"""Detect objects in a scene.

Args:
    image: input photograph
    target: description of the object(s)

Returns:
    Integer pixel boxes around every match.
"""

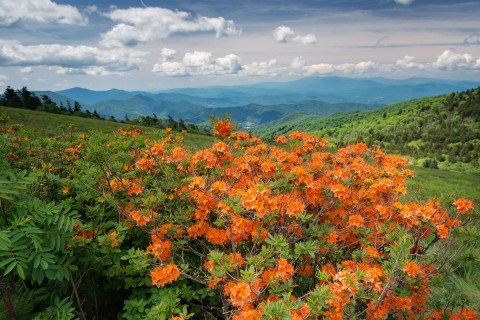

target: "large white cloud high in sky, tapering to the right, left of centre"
[101,7,241,48]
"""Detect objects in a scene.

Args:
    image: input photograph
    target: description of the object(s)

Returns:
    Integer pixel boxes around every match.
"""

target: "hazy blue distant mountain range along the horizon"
[36,77,479,128]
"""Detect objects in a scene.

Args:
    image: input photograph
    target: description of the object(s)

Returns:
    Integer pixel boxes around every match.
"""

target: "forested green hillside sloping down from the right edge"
[258,88,480,169]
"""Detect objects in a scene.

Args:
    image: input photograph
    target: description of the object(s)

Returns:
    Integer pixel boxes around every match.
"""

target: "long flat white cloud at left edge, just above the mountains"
[0,41,148,75]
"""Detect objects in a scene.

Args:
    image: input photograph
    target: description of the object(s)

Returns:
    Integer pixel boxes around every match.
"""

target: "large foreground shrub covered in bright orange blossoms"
[106,119,476,319]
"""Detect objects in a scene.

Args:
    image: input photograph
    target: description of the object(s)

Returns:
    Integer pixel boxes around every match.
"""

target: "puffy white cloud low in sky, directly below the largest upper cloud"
[152,50,243,76]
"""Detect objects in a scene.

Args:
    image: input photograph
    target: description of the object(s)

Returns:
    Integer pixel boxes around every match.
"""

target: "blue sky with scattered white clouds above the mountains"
[0,0,480,91]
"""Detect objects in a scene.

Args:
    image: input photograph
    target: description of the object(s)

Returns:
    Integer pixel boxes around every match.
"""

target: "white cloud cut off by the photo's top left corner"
[0,0,87,27]
